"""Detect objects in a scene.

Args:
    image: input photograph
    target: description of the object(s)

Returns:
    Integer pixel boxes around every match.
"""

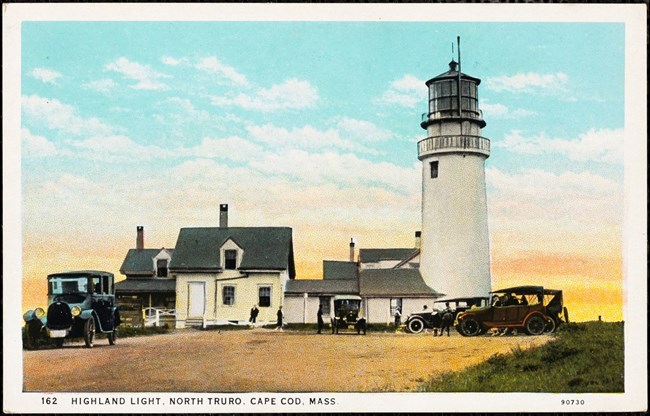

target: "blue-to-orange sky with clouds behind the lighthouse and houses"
[20,21,625,321]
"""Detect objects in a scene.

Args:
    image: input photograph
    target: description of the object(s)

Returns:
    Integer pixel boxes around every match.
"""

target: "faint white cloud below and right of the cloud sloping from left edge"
[68,135,177,163]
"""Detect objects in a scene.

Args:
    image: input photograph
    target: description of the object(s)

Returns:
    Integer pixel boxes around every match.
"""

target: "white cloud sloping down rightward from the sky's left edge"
[21,95,113,135]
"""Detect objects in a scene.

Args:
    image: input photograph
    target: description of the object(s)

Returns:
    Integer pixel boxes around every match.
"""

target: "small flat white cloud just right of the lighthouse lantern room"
[485,72,569,95]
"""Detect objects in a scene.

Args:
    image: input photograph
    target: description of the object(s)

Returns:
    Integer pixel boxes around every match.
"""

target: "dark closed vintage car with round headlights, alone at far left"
[23,270,120,348]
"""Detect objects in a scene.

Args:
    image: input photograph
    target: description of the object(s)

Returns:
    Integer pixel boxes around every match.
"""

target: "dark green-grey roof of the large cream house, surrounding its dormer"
[169,227,296,279]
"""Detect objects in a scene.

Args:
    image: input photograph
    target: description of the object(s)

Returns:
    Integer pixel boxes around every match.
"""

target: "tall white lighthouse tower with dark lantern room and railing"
[418,38,491,297]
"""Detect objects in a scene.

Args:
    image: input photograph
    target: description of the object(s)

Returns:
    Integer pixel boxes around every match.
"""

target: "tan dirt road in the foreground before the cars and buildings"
[23,328,549,392]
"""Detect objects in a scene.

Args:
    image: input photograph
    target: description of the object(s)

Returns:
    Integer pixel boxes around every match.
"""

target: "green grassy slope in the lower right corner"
[420,322,625,393]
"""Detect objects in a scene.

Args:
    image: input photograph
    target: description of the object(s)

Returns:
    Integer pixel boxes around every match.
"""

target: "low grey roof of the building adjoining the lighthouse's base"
[359,269,443,297]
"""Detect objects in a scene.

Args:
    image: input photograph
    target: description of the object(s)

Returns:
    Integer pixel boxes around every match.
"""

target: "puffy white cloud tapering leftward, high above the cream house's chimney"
[211,78,318,111]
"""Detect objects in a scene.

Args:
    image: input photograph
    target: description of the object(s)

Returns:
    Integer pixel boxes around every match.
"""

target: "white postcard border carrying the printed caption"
[2,3,647,413]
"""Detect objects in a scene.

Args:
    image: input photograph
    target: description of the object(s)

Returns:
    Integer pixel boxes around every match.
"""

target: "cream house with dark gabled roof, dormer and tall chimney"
[169,205,296,328]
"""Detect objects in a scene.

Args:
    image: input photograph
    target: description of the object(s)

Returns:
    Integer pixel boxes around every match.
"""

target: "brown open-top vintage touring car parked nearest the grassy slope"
[456,286,569,336]
